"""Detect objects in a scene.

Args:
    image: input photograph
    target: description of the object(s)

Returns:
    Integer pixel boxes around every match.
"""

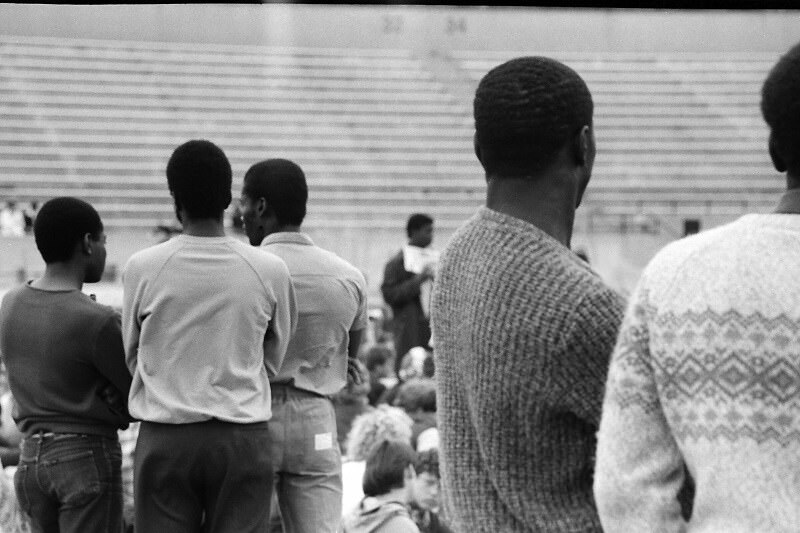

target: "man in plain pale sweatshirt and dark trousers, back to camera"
[123,141,297,533]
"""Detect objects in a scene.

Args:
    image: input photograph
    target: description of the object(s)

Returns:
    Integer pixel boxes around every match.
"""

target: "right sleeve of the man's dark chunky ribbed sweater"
[554,288,625,428]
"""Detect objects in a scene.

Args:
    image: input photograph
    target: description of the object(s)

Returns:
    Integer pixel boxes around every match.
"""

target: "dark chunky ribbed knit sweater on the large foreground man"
[432,208,623,533]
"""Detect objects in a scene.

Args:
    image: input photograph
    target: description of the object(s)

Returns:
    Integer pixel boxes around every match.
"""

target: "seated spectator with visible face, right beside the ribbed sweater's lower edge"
[408,449,452,533]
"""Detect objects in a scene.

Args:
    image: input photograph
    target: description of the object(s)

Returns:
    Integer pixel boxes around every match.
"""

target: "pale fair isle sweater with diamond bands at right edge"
[595,214,800,533]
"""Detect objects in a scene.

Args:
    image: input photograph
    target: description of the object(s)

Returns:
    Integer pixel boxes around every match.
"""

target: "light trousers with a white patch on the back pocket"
[269,384,342,533]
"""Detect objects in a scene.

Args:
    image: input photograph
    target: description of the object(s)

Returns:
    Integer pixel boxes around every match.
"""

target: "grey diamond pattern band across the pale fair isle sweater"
[615,309,800,445]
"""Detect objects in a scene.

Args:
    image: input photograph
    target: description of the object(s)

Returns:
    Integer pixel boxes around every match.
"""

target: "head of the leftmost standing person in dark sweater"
[33,197,106,283]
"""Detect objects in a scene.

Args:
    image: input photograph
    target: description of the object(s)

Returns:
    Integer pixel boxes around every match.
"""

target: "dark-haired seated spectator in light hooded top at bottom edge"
[344,440,419,533]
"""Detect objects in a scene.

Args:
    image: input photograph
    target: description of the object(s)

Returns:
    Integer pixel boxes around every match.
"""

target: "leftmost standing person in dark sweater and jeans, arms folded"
[0,197,131,533]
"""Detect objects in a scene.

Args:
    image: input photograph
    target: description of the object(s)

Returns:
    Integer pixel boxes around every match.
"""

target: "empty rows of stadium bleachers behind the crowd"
[0,36,783,228]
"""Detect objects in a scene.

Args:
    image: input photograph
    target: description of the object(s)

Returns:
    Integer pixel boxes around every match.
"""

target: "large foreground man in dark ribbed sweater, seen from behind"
[432,57,623,533]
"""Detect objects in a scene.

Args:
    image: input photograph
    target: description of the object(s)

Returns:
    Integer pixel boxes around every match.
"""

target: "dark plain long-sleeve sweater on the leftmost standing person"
[0,284,131,436]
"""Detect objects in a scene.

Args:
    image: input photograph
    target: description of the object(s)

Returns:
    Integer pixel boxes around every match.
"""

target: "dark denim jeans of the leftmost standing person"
[14,433,122,533]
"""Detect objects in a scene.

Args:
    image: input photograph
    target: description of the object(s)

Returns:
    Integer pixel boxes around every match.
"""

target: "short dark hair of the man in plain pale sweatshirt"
[167,140,232,219]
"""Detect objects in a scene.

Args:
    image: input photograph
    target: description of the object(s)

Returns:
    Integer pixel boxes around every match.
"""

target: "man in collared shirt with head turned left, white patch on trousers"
[241,159,368,533]
